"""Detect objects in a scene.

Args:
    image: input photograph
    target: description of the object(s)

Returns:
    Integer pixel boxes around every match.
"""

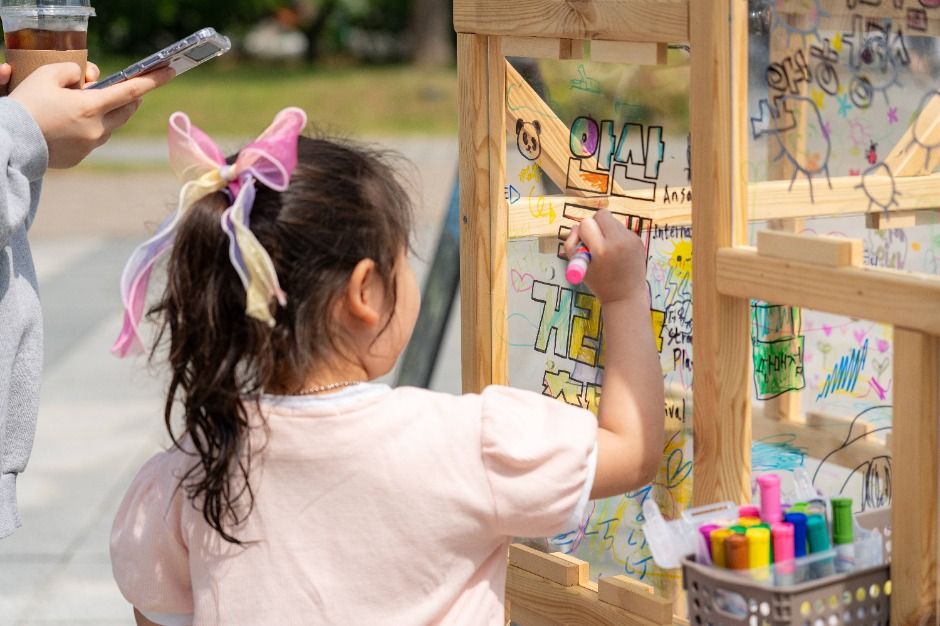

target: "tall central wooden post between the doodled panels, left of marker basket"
[689,0,751,505]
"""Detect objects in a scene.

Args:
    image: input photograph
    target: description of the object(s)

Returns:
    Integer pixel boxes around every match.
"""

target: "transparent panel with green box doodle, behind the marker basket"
[751,302,893,512]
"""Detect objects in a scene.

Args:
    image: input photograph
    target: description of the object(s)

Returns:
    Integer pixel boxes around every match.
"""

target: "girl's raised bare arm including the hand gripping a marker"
[565,211,664,498]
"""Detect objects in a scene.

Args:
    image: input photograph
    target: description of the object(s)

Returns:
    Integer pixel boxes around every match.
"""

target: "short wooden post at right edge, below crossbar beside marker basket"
[891,328,940,626]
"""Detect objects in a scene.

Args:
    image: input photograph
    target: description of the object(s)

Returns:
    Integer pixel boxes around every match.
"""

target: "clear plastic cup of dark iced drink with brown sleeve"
[0,0,95,90]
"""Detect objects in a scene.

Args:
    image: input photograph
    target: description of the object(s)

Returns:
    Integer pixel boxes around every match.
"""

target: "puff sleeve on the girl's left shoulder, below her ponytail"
[111,452,193,615]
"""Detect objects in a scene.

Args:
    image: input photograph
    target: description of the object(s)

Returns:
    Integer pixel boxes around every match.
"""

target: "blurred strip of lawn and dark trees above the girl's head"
[82,0,457,136]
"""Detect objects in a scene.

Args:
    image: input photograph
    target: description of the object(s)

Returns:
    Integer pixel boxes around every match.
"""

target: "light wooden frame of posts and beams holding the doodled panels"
[454,0,940,624]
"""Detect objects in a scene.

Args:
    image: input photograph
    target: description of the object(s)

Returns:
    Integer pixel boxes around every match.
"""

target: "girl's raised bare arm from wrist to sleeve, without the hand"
[592,292,664,497]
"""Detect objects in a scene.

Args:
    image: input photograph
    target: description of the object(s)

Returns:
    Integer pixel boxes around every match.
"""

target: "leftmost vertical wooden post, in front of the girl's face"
[457,34,508,393]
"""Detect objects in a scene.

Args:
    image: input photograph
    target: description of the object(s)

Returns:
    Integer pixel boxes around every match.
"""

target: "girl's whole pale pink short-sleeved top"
[111,385,597,626]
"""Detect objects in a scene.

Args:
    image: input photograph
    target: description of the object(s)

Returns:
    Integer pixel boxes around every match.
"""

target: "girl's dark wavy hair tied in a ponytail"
[150,137,412,544]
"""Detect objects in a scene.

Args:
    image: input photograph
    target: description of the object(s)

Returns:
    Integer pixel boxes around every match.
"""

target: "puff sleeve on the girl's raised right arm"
[480,387,597,537]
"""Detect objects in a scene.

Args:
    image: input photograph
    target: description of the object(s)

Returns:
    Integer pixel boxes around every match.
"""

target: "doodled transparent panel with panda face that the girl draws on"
[506,49,692,595]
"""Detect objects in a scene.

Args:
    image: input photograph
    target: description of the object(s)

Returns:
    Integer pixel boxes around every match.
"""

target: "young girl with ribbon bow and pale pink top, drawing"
[111,109,663,625]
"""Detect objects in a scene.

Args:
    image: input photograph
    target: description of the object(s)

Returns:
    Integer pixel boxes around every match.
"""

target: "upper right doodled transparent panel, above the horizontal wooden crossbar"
[748,0,940,241]
